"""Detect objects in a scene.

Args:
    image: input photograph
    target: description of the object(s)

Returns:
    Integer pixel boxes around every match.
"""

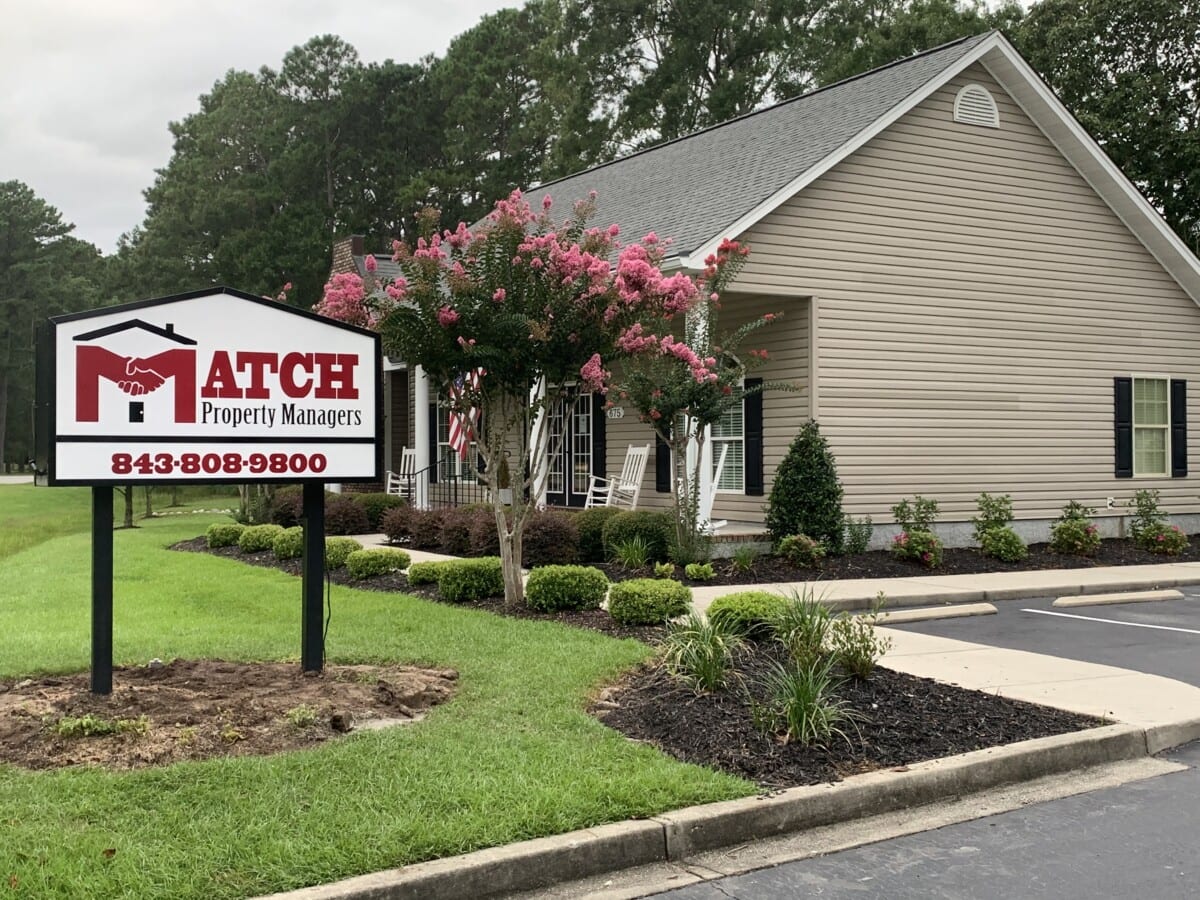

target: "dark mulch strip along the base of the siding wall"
[599,538,1200,586]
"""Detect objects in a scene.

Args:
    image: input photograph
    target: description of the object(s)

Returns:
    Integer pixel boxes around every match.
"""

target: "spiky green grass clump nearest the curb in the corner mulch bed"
[755,660,858,746]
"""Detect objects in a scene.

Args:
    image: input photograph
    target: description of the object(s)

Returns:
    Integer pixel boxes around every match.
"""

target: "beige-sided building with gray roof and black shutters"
[333,32,1200,542]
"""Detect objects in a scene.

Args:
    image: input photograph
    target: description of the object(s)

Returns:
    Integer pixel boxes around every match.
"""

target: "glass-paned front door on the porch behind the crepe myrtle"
[546,392,604,506]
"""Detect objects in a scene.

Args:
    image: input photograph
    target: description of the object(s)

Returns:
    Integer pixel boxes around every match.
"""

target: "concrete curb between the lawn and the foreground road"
[255,718,1200,900]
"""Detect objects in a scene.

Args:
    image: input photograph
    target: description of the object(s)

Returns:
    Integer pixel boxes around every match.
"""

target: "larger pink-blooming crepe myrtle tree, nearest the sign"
[316,191,696,605]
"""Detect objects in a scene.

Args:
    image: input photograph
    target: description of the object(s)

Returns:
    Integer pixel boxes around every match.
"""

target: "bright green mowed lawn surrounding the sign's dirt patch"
[0,496,755,898]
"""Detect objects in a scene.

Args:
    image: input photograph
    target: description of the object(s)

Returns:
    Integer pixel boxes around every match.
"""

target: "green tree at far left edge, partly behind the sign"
[0,181,102,466]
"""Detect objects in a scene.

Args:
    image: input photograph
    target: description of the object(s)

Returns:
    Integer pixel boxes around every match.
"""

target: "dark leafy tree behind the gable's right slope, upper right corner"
[1016,0,1200,253]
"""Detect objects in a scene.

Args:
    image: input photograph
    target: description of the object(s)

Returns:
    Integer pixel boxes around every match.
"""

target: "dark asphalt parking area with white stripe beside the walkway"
[889,595,1200,686]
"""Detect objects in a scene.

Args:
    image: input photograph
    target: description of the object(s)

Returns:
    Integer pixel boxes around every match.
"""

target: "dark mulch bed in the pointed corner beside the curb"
[593,648,1104,787]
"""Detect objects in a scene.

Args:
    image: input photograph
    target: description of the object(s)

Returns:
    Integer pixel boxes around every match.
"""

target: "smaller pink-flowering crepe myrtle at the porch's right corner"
[610,240,797,562]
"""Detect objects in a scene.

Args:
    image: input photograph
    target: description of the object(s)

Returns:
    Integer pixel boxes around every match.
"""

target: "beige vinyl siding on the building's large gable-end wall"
[738,66,1200,522]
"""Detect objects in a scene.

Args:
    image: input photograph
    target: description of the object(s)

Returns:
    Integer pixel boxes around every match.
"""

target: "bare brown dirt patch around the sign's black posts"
[0,660,458,769]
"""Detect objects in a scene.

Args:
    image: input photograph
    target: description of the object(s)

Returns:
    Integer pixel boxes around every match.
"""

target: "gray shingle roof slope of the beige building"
[529,32,994,256]
